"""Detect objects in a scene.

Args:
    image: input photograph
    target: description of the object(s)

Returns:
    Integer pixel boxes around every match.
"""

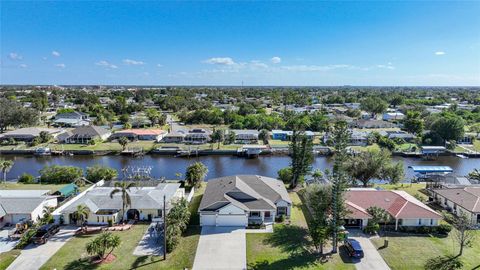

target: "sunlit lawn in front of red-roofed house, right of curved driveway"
[372,231,480,270]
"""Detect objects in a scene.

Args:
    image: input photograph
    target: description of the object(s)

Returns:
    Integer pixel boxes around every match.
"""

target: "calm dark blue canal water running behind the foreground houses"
[2,155,480,179]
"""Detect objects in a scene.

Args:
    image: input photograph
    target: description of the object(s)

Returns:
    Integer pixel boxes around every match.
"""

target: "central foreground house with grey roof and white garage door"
[198,175,292,227]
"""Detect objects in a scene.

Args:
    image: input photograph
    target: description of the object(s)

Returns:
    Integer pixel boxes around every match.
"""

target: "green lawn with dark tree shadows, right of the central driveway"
[247,193,355,270]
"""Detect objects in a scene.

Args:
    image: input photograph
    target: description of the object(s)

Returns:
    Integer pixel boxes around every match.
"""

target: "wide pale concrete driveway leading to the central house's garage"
[193,226,247,270]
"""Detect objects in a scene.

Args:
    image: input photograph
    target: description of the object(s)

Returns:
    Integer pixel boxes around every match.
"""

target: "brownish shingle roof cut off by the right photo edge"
[433,187,480,213]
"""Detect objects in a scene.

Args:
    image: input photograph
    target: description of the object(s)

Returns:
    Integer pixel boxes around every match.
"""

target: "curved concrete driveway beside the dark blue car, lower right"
[350,235,390,270]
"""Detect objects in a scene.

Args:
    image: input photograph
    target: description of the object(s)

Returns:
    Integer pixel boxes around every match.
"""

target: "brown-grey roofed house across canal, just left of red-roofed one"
[57,126,112,144]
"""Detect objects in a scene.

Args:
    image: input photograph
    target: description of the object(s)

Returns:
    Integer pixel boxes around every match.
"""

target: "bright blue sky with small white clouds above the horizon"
[0,0,480,86]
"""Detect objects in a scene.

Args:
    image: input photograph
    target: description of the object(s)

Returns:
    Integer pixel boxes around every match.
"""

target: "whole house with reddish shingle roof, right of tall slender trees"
[345,188,442,230]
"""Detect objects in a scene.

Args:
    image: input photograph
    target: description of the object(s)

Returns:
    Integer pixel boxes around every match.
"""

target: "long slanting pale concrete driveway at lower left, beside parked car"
[7,227,78,270]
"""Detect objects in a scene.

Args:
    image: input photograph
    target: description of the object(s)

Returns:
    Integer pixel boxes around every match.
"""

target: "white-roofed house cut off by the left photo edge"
[0,190,57,228]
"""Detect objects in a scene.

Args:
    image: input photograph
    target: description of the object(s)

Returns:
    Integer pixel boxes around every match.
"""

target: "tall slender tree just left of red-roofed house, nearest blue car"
[330,121,351,253]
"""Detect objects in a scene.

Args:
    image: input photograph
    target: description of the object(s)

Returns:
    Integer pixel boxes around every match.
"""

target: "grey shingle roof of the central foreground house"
[199,175,291,211]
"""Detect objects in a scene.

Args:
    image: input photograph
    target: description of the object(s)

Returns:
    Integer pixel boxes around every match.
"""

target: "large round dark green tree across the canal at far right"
[430,116,465,143]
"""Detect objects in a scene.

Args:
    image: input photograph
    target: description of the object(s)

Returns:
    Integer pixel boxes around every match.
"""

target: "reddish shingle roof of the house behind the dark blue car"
[345,189,442,219]
